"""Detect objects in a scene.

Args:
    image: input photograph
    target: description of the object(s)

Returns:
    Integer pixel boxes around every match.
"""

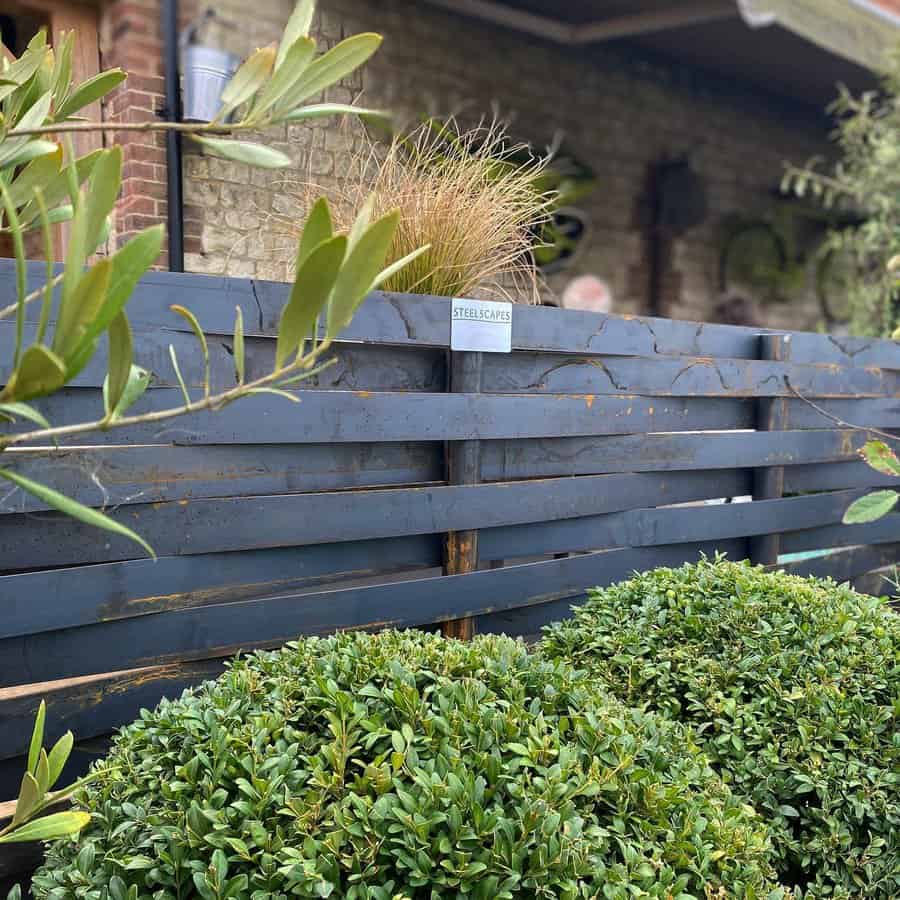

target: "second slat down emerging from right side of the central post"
[481,429,867,486]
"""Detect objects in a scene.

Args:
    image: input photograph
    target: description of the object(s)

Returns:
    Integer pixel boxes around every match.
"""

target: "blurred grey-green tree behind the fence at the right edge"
[784,54,900,336]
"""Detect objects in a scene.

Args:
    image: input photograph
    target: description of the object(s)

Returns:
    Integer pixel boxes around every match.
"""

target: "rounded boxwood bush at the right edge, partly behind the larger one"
[542,559,900,900]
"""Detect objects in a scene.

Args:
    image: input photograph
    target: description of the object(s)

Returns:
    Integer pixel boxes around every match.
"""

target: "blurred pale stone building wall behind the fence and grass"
[179,0,827,328]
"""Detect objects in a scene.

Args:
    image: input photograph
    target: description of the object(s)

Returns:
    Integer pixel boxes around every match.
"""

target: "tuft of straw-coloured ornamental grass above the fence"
[255,120,554,302]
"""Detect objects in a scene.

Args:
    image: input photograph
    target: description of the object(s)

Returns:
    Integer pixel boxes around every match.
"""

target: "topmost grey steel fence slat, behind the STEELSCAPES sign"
[7,260,900,369]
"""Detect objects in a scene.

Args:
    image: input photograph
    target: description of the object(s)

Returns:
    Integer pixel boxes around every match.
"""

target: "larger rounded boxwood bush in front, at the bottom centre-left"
[34,632,783,900]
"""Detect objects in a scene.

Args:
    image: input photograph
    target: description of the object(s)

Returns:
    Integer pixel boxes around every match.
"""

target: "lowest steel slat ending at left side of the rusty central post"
[0,535,441,638]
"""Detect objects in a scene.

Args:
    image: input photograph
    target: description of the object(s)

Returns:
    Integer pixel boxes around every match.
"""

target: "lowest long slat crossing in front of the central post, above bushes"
[0,544,744,685]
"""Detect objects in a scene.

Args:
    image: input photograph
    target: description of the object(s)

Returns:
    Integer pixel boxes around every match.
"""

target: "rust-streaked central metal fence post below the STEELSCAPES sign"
[441,350,482,640]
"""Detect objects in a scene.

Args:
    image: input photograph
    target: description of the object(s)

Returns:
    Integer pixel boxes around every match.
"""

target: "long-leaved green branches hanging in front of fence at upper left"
[0,0,426,555]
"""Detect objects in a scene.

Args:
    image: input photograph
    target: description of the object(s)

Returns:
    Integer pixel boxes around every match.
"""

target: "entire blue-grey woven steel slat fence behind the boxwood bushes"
[0,264,900,816]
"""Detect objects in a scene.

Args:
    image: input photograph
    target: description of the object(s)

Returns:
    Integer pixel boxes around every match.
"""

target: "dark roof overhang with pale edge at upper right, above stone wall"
[428,0,888,109]
